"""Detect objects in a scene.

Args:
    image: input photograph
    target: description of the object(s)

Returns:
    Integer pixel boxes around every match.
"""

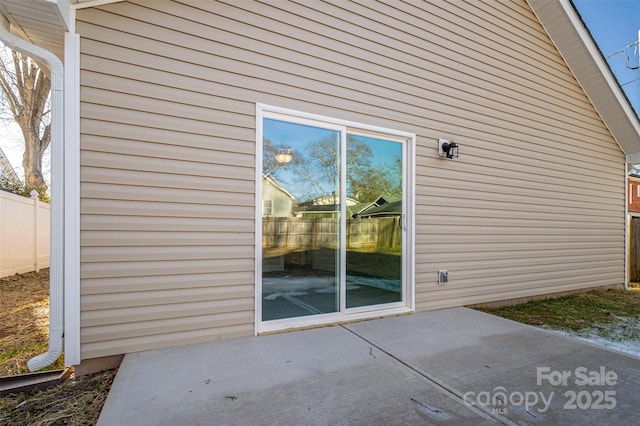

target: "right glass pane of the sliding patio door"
[346,134,405,308]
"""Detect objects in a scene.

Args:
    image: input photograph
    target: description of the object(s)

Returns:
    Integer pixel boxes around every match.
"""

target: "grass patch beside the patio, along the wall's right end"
[478,286,640,337]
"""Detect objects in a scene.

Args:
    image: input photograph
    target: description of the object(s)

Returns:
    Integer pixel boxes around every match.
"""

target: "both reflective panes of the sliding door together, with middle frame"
[261,113,406,321]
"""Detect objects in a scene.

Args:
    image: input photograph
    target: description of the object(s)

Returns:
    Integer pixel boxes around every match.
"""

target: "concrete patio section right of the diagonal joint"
[346,308,640,425]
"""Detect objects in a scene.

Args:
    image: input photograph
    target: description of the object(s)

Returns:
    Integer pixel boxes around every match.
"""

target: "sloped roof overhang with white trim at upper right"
[527,0,640,162]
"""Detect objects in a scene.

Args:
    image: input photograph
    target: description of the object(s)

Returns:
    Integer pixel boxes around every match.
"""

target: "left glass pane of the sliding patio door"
[262,119,341,321]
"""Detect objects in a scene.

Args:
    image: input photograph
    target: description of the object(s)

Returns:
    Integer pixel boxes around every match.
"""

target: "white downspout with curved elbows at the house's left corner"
[0,20,64,371]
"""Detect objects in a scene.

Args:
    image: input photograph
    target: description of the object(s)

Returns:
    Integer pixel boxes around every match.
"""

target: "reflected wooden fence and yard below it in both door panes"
[262,217,402,321]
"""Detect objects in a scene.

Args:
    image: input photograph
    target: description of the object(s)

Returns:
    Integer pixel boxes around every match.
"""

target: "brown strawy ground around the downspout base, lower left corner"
[0,269,115,426]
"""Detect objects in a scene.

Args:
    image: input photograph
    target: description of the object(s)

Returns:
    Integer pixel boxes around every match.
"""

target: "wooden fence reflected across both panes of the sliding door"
[262,217,402,250]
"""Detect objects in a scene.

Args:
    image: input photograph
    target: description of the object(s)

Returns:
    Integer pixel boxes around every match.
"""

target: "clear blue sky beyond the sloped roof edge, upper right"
[573,0,640,115]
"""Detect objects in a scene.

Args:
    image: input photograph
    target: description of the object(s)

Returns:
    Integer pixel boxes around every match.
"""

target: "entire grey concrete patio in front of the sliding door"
[98,308,640,426]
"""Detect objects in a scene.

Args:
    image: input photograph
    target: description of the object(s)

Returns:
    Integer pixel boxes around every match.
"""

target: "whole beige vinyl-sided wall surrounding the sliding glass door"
[77,0,625,358]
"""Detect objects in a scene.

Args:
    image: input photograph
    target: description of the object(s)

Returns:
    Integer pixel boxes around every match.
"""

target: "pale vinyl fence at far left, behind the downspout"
[0,191,51,278]
